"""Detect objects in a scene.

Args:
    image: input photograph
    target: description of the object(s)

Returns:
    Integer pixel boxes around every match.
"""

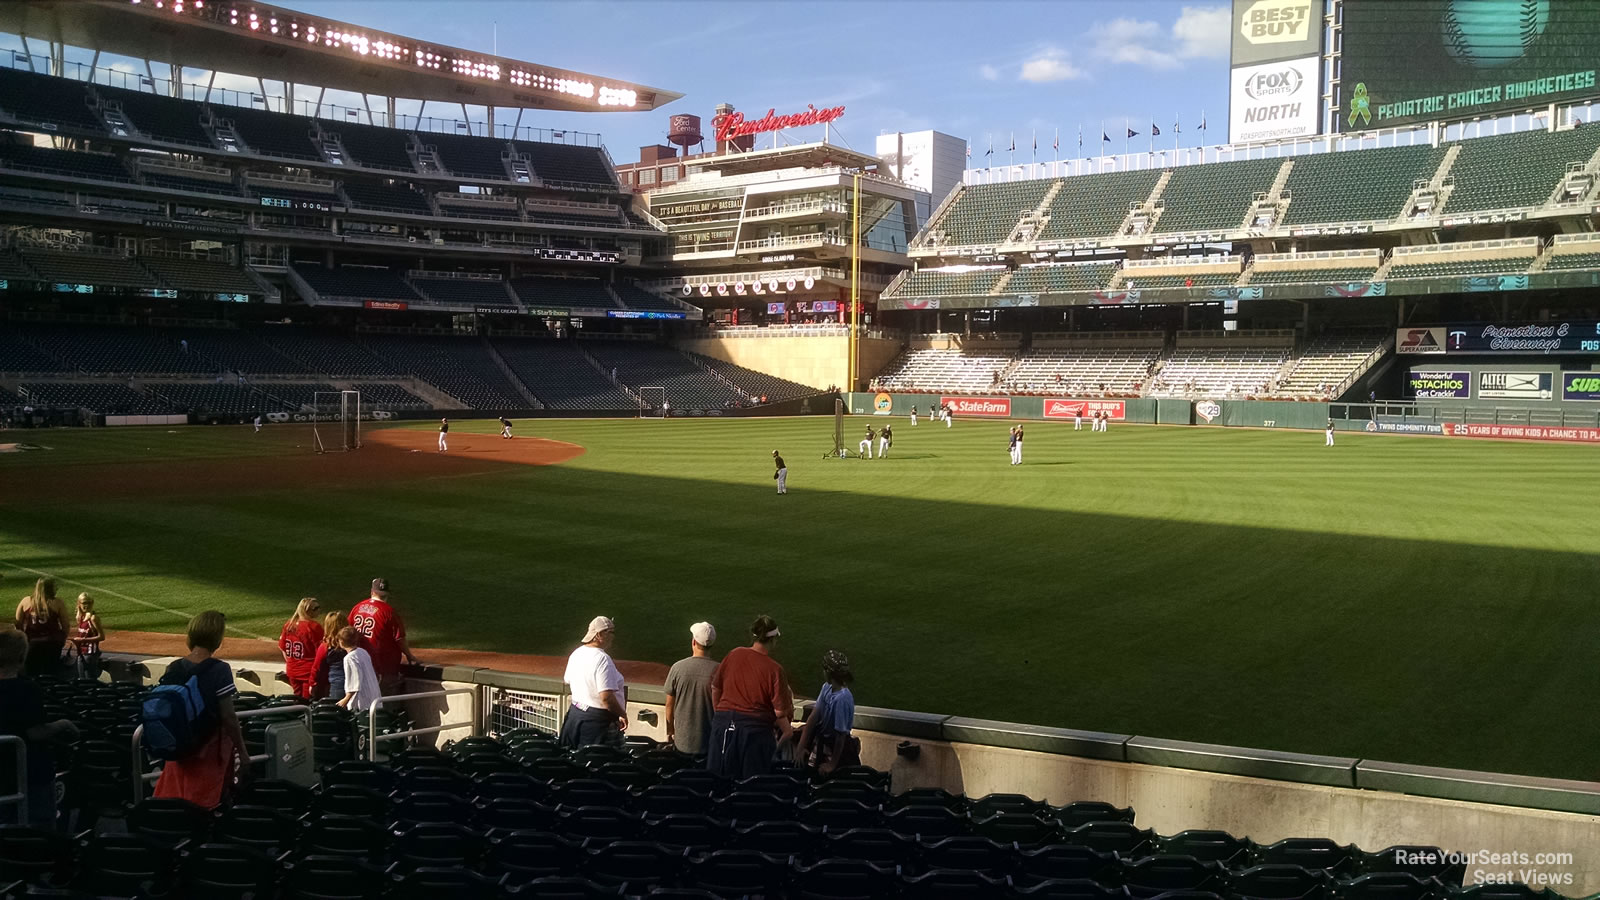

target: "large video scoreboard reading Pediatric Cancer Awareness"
[1336,0,1600,131]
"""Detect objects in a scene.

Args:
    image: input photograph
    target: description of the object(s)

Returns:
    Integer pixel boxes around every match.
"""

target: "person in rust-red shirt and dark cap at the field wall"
[706,615,795,778]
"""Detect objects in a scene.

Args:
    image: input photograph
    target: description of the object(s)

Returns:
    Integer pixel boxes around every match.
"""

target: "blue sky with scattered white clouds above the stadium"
[294,0,1229,165]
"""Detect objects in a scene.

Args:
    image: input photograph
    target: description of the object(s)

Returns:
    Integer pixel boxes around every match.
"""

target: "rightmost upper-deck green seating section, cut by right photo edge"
[1445,128,1600,213]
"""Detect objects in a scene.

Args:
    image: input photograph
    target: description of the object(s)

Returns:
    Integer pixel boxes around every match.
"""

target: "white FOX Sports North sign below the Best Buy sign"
[1227,56,1322,144]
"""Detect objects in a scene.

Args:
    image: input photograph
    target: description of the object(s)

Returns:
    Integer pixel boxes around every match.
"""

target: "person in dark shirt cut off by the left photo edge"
[0,628,78,828]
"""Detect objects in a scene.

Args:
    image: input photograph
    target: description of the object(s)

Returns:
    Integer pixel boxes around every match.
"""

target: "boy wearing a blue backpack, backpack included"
[141,610,246,809]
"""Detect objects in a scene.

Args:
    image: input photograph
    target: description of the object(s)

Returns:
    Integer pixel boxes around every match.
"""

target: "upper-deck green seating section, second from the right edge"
[1283,146,1445,226]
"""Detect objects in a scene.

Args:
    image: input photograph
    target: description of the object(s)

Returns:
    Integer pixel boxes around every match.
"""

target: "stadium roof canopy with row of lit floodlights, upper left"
[0,0,683,112]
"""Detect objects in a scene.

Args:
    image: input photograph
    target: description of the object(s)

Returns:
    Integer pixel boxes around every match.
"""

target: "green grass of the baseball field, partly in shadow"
[0,416,1600,778]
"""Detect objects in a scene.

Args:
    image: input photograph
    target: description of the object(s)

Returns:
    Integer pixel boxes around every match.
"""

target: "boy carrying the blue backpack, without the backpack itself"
[155,610,246,809]
